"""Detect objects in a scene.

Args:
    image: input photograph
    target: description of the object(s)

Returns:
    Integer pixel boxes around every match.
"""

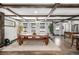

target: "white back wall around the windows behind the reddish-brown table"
[21,21,52,35]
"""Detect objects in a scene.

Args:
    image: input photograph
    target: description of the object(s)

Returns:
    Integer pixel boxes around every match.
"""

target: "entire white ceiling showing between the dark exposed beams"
[0,8,79,19]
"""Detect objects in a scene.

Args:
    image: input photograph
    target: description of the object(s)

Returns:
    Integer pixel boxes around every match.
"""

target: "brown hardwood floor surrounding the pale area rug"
[0,36,79,55]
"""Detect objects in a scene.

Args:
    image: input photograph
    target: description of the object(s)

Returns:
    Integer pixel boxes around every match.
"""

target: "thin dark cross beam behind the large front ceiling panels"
[5,15,79,17]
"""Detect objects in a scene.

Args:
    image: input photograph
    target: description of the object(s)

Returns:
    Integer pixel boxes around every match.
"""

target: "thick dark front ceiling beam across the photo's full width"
[0,3,79,8]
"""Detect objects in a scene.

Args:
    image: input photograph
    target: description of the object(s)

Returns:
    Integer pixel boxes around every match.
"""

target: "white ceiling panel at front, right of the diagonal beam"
[52,8,79,15]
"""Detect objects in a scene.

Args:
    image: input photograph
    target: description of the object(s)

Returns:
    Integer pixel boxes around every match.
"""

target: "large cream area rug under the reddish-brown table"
[0,40,61,51]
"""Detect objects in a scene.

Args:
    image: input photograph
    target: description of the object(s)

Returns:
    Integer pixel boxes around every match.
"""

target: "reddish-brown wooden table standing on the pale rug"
[17,35,49,45]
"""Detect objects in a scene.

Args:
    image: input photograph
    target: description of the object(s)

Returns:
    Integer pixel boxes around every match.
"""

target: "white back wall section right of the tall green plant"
[54,21,72,35]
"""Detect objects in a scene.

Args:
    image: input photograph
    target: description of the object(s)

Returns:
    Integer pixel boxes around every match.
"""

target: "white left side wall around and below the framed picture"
[5,18,18,40]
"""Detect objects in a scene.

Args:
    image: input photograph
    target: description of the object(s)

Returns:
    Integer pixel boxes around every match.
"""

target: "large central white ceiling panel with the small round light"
[10,8,51,15]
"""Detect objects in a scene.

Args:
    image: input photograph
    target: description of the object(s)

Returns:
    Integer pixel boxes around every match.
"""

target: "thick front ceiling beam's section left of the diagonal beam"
[0,3,54,8]
